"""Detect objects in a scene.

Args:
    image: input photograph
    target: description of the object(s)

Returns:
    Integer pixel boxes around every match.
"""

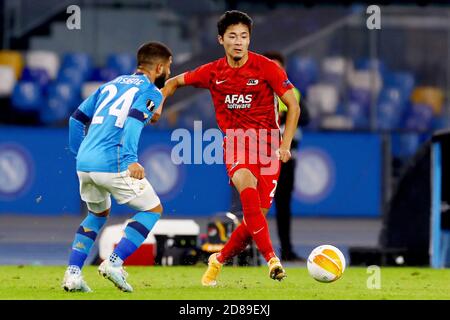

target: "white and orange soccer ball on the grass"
[307,245,345,282]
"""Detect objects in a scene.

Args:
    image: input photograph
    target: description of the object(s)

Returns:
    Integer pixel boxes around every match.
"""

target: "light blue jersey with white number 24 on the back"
[69,74,163,172]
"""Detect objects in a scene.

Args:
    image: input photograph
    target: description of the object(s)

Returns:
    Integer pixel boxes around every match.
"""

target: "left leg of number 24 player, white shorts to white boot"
[62,172,111,292]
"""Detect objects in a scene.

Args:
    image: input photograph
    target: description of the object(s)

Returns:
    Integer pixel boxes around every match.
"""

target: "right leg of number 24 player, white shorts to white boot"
[99,177,163,292]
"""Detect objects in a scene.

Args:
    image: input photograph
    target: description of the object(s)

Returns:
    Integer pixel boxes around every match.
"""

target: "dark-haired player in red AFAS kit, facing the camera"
[162,10,300,286]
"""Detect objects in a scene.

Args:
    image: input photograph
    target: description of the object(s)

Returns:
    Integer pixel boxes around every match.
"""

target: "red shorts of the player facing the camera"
[224,139,281,209]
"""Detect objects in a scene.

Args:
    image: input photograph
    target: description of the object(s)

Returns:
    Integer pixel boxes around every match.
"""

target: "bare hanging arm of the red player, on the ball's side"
[280,89,300,162]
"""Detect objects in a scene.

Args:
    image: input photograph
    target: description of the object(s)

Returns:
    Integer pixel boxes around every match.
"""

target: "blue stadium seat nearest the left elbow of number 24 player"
[41,82,80,125]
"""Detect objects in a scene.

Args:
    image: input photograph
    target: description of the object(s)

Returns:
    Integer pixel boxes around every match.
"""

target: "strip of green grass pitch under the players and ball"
[0,266,450,300]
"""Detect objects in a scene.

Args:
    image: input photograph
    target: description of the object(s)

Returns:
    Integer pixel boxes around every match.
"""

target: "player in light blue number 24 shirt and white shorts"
[62,42,172,292]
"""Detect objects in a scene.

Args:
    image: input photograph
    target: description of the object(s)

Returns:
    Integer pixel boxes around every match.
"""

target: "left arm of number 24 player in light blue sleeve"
[69,90,98,155]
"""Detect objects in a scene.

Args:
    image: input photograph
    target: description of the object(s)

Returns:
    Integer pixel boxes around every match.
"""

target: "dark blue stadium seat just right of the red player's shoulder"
[286,56,319,95]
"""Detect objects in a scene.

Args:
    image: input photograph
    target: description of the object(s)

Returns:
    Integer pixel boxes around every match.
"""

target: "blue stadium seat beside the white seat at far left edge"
[11,81,44,111]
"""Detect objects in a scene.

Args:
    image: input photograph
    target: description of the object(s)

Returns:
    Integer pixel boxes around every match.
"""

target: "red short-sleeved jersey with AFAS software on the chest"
[184,51,293,133]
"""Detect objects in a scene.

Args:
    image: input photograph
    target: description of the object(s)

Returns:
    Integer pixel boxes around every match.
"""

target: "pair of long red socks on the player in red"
[217,188,275,263]
